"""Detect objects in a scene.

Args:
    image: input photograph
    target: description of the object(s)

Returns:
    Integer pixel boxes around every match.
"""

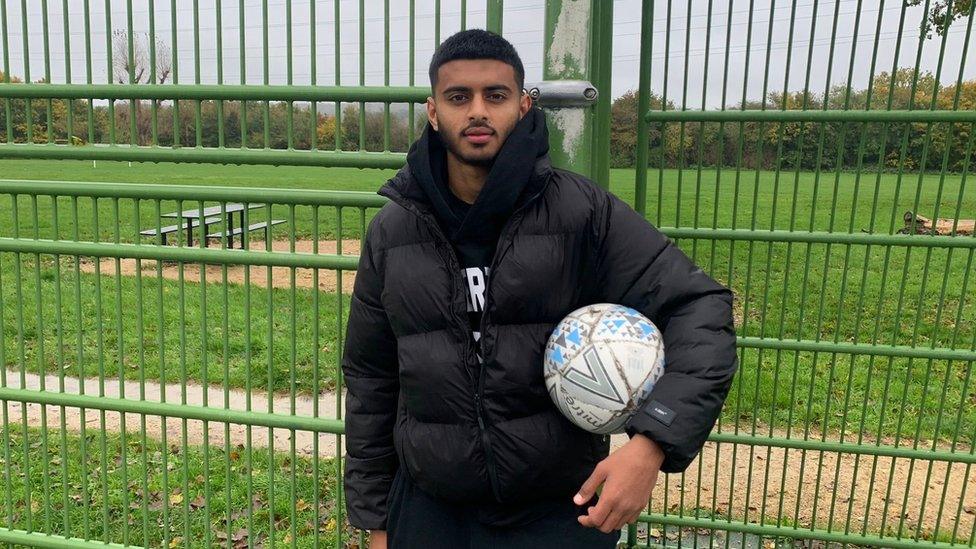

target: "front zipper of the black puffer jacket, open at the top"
[380,181,549,502]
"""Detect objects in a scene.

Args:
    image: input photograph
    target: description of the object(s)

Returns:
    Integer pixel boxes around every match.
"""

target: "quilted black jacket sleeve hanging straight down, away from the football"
[342,226,399,530]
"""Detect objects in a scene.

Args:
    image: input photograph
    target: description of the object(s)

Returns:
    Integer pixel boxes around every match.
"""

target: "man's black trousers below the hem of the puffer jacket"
[386,467,620,549]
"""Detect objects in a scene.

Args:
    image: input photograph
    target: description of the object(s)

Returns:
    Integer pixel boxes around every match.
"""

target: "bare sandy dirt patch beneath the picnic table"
[81,239,359,294]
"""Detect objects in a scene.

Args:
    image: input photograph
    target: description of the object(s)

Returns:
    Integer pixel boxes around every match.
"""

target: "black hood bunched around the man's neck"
[379,107,552,242]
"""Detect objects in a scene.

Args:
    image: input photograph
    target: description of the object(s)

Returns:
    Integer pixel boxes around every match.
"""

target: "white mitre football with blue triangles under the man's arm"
[543,303,664,434]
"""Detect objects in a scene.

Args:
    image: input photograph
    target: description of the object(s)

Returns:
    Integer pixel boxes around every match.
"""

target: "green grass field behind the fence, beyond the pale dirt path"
[0,155,976,442]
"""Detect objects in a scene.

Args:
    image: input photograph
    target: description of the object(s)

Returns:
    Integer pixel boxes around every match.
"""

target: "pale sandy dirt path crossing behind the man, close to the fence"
[7,372,976,538]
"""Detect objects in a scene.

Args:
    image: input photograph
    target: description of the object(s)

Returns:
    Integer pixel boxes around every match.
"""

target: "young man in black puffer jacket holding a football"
[342,30,736,549]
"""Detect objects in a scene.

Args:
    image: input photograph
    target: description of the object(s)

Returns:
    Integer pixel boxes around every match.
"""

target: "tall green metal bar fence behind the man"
[0,0,976,547]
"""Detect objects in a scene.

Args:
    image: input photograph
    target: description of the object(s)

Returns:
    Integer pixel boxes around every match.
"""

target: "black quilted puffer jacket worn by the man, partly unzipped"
[342,109,736,529]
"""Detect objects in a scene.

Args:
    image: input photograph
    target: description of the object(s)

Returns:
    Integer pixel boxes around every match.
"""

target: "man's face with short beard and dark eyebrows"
[427,59,532,166]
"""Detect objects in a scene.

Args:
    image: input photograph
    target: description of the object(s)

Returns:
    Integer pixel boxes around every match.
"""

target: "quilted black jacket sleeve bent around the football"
[594,189,738,473]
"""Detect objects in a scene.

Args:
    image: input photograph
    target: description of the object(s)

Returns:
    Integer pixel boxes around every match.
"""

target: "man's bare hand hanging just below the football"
[573,434,664,534]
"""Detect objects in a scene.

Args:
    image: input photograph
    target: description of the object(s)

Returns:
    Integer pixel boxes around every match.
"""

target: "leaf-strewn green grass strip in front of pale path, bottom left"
[0,426,353,548]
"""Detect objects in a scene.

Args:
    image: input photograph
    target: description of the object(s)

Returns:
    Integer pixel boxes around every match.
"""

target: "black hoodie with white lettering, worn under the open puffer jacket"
[407,108,549,357]
